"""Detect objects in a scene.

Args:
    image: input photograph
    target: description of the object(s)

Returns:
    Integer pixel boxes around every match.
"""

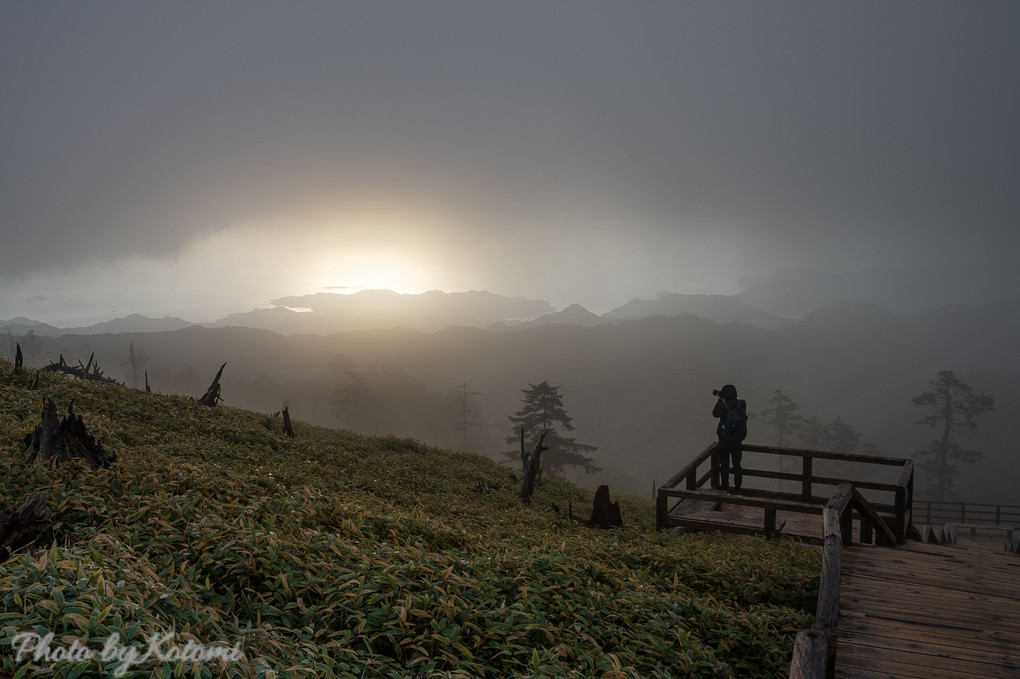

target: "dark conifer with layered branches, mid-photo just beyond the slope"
[506,381,600,473]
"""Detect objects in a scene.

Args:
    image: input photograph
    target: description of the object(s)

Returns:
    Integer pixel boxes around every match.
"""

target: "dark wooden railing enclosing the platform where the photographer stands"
[656,443,914,543]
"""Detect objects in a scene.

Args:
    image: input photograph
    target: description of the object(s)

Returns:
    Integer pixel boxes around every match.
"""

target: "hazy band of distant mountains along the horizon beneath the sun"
[0,268,1010,336]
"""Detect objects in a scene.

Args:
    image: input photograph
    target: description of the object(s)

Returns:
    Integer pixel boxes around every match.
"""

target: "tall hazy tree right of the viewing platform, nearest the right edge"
[913,370,996,501]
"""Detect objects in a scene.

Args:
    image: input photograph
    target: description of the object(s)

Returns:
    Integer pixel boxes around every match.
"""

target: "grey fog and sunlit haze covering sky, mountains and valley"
[0,0,1020,504]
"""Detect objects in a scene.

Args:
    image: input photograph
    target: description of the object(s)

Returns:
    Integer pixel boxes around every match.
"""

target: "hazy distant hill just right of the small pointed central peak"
[604,293,792,328]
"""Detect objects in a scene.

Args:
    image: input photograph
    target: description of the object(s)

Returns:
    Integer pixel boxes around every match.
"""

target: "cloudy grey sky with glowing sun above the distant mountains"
[0,0,1020,324]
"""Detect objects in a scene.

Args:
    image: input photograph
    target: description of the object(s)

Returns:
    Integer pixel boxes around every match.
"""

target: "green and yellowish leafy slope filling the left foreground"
[0,362,819,677]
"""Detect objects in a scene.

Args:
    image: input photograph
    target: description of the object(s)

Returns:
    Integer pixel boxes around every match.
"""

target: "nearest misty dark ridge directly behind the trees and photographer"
[9,291,1020,502]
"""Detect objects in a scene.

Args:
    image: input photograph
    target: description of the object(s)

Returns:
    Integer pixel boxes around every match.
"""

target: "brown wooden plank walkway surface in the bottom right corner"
[835,540,1020,679]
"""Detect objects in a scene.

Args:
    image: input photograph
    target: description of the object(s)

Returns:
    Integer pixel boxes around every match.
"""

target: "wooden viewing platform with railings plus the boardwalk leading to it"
[656,445,1020,679]
